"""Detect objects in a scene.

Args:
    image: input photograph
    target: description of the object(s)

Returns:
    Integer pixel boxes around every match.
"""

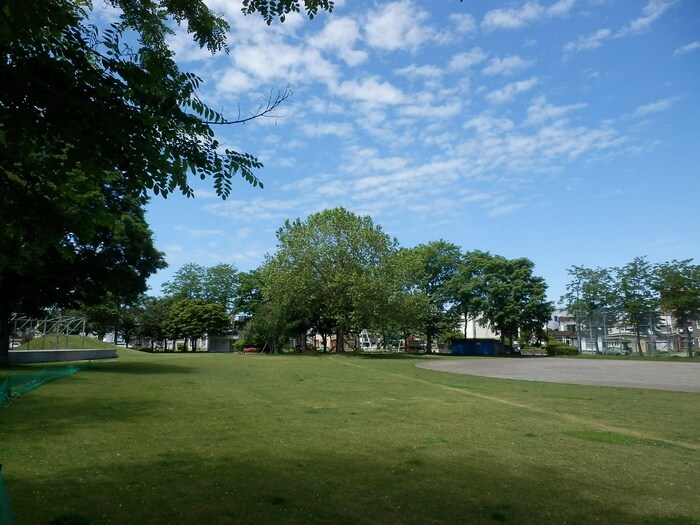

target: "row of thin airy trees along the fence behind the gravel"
[561,257,700,356]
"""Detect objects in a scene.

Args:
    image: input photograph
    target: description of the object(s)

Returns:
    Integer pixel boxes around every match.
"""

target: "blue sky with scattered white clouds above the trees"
[135,0,700,300]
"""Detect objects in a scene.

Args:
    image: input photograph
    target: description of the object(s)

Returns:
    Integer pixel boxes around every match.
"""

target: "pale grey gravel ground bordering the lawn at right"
[418,357,700,392]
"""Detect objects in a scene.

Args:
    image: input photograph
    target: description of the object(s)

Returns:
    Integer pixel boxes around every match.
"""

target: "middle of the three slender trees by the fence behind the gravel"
[614,257,659,356]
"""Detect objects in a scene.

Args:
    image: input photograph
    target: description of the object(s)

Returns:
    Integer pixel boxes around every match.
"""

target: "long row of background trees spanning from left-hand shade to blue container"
[69,208,552,352]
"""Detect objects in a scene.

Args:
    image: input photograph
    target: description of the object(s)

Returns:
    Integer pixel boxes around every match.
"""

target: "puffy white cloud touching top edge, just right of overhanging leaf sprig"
[364,0,435,51]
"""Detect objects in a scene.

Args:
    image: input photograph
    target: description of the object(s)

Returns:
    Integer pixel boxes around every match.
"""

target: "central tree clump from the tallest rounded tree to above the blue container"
[236,208,552,351]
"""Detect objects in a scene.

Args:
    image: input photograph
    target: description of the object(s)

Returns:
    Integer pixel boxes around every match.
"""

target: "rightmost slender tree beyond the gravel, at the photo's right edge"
[653,259,700,357]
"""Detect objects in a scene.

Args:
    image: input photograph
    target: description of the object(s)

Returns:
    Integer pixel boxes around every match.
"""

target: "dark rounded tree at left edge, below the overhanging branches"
[0,175,165,365]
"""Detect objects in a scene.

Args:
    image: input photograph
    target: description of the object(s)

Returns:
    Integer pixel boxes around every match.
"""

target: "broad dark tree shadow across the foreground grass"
[6,444,697,525]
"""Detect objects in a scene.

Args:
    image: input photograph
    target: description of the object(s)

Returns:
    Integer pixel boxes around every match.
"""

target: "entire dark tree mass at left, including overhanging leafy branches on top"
[0,0,333,365]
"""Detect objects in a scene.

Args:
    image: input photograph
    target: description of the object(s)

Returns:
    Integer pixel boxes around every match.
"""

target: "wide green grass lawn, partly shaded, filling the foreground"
[0,350,700,525]
